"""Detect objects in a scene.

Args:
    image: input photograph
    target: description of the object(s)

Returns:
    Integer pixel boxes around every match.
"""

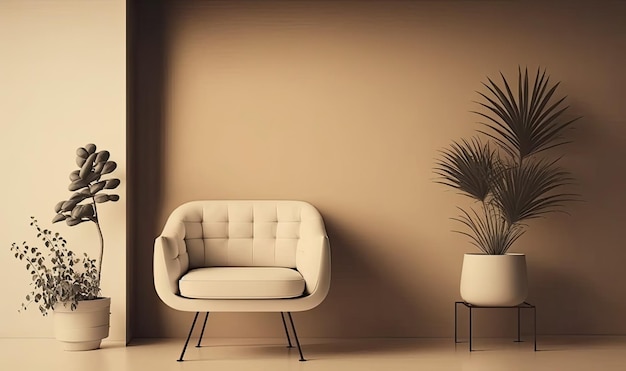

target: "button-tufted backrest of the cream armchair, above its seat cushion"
[161,200,326,269]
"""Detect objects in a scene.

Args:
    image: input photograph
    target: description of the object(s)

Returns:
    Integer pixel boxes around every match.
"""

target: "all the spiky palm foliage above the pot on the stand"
[434,67,579,255]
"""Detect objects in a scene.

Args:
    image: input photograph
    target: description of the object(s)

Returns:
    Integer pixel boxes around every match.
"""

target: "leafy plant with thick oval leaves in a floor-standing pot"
[11,144,120,350]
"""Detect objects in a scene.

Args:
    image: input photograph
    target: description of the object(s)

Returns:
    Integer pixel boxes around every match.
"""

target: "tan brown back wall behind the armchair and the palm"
[134,1,626,337]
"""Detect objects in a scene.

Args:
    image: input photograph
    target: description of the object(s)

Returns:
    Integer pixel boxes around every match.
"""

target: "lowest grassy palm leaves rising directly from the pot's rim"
[452,203,524,255]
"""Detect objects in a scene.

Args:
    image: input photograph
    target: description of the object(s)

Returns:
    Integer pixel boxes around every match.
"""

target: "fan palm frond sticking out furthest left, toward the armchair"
[434,138,498,201]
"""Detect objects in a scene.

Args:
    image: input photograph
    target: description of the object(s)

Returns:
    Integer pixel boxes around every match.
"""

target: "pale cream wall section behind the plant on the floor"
[0,0,126,341]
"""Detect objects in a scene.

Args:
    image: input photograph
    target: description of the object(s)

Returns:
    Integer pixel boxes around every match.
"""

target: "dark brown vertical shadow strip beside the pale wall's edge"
[127,1,167,337]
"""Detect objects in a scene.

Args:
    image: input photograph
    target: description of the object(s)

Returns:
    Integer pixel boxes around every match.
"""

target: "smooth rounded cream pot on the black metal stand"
[461,253,528,307]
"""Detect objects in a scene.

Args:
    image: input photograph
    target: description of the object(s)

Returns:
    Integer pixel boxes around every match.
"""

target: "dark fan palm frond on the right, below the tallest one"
[493,159,576,224]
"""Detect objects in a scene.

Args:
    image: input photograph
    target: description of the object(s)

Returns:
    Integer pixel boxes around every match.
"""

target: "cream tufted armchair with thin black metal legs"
[154,200,330,361]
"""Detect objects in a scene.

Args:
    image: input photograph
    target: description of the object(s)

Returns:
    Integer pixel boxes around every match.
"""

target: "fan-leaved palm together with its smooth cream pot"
[435,68,578,306]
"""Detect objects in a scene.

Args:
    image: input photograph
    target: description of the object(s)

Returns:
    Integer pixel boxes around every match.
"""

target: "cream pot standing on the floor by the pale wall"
[53,298,111,351]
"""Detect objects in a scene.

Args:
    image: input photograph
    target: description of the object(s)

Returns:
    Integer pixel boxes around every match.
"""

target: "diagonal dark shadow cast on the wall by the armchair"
[302,215,420,337]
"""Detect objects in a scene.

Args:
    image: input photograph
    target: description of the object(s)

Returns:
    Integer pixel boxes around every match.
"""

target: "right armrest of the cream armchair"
[296,235,331,307]
